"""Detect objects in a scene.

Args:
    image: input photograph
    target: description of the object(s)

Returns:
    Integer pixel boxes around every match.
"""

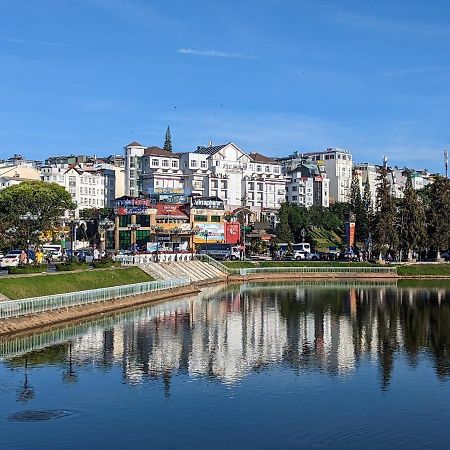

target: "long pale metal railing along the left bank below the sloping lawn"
[0,278,190,319]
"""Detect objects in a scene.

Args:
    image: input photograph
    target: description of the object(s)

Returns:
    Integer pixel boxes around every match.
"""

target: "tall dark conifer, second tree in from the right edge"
[399,173,426,260]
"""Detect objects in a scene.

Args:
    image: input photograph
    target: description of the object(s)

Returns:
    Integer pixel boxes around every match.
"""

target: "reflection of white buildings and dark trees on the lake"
[0,283,450,392]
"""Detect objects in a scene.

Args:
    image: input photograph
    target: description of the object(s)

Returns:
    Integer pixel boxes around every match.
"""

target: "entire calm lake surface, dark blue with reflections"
[0,282,450,449]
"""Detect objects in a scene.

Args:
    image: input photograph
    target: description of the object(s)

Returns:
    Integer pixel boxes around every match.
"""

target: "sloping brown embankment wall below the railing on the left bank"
[0,285,200,336]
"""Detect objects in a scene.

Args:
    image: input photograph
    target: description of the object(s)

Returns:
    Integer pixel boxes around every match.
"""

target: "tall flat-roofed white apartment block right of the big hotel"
[303,148,352,203]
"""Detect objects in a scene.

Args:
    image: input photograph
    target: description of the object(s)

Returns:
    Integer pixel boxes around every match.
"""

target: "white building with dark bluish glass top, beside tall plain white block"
[286,160,330,208]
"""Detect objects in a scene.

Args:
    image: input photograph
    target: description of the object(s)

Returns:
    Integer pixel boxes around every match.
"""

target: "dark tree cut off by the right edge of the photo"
[427,177,450,258]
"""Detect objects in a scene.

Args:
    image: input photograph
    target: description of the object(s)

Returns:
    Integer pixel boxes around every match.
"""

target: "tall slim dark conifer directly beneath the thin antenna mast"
[373,168,398,255]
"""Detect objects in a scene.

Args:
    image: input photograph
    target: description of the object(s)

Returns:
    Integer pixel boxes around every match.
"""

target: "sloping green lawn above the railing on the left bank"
[0,267,152,299]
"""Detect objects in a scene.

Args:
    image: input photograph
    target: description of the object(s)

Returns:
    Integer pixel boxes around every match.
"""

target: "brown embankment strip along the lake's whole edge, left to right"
[0,273,450,337]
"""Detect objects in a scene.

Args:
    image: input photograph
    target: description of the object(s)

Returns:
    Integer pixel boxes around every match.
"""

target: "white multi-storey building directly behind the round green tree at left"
[41,164,106,210]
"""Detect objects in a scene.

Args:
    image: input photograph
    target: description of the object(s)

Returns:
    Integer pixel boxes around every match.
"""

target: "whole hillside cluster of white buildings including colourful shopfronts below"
[0,142,432,249]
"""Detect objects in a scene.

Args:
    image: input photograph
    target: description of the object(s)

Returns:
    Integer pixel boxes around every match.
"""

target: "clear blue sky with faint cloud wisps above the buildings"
[0,0,450,171]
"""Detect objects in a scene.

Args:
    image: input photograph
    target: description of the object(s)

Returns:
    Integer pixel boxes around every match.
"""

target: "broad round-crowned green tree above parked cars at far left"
[0,181,75,248]
